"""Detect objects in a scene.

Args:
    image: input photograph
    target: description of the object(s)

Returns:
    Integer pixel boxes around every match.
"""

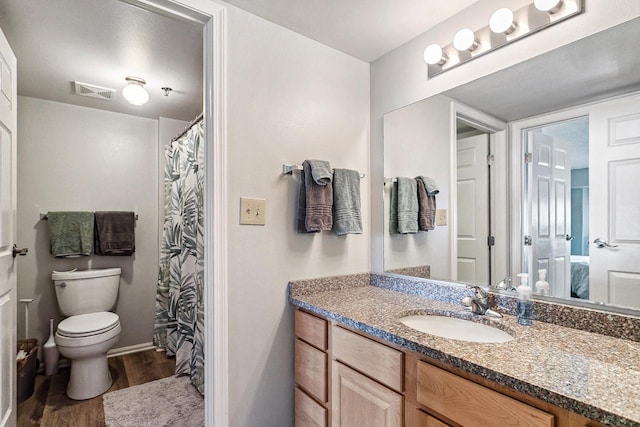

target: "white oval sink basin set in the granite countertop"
[400,314,513,343]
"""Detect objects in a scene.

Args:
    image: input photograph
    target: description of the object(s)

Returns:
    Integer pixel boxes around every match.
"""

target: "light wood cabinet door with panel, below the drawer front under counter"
[331,361,403,427]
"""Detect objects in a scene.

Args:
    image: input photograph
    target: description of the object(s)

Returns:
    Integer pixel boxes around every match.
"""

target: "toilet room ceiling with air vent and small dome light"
[0,0,203,121]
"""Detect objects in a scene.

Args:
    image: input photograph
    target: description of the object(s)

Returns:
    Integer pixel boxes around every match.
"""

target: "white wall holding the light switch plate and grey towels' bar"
[227,6,369,427]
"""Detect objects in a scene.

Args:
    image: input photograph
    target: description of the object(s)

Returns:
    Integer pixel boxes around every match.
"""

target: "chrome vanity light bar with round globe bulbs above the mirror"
[424,0,585,78]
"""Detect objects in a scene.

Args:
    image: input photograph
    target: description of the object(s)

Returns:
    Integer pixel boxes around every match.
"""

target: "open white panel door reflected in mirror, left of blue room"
[527,128,571,298]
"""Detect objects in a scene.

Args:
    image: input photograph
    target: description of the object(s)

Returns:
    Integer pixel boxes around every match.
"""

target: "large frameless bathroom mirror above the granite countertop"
[384,18,640,309]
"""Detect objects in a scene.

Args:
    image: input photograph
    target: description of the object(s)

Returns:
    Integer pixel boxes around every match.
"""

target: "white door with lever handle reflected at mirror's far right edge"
[589,95,640,308]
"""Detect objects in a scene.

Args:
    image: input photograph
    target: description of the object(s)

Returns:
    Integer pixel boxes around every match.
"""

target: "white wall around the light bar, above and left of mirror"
[370,0,640,271]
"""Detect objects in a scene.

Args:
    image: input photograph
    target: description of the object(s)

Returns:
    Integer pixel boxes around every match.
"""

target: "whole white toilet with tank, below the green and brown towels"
[51,268,121,400]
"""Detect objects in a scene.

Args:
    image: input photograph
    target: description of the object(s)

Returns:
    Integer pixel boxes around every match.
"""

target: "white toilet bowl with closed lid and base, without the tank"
[55,312,122,400]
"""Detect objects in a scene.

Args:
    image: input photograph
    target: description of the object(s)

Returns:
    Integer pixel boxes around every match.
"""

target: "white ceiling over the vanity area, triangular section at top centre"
[226,0,478,62]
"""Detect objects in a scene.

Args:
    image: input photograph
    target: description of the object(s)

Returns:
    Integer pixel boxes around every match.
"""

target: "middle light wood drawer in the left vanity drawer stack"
[295,339,327,403]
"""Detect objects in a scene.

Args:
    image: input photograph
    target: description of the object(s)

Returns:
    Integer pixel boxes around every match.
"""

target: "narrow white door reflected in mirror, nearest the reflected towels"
[456,134,489,285]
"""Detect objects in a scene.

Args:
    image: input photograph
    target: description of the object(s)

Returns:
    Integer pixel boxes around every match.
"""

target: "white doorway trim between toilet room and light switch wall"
[121,0,229,427]
